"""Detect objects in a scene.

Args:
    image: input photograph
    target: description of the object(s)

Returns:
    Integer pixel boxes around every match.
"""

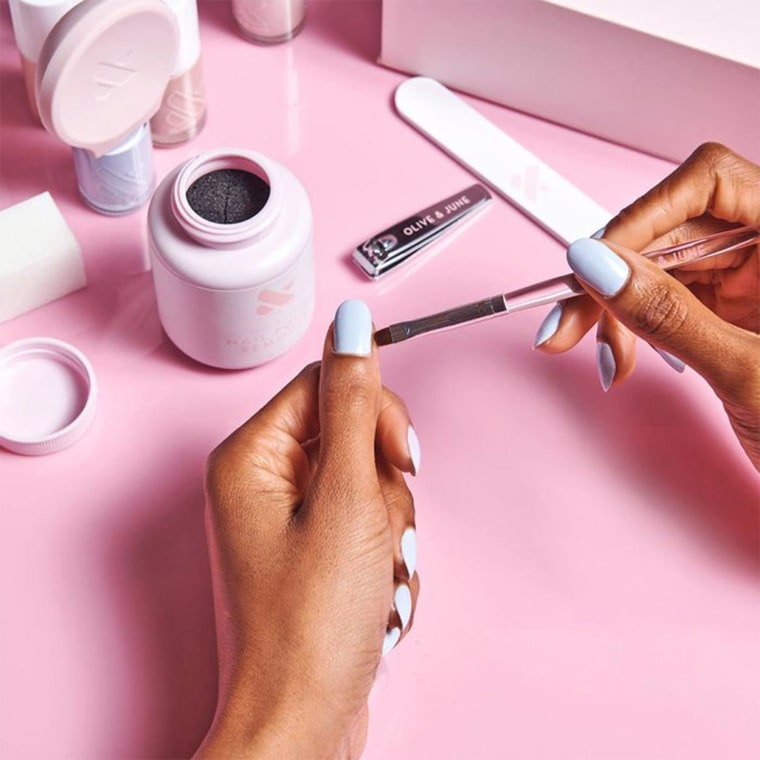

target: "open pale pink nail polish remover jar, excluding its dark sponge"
[148,150,314,369]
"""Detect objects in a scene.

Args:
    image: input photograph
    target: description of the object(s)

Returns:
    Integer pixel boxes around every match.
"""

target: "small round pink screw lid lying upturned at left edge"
[0,338,97,455]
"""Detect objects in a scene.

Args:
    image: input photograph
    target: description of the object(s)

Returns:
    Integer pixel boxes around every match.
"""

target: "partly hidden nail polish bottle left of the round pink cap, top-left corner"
[9,0,79,121]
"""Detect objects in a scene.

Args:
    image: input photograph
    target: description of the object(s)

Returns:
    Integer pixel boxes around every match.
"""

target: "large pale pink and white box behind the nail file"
[380,0,760,161]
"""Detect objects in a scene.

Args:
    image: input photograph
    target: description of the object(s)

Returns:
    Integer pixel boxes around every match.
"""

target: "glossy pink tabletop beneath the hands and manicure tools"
[0,0,760,760]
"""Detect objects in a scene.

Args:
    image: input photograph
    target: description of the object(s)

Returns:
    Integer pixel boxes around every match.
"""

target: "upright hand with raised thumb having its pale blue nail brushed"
[198,301,419,759]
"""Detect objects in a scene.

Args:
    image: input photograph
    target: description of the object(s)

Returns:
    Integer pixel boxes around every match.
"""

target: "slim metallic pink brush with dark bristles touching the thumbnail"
[375,225,760,346]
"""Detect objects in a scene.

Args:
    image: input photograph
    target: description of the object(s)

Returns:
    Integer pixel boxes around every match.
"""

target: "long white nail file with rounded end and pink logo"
[395,77,612,245]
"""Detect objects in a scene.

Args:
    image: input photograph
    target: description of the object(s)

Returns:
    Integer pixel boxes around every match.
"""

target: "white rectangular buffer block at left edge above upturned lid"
[0,193,87,322]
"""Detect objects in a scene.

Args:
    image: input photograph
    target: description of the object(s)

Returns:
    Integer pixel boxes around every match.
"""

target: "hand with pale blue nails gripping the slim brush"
[535,143,760,470]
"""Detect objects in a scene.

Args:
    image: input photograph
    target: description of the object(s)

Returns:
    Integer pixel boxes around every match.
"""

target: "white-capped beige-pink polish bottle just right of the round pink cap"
[150,0,206,147]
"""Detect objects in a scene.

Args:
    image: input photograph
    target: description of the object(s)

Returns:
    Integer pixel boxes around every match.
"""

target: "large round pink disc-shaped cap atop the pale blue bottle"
[36,0,179,155]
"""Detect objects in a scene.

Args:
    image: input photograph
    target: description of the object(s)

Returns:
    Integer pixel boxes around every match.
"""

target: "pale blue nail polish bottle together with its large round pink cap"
[35,0,179,215]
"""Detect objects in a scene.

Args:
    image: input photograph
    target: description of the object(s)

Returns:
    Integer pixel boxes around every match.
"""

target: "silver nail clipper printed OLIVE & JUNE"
[354,185,491,278]
